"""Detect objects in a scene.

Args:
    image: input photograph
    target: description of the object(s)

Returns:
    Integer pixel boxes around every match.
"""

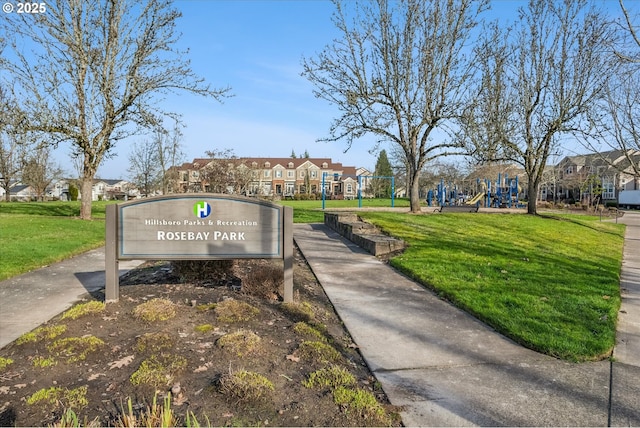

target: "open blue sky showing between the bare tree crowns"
[84,0,640,178]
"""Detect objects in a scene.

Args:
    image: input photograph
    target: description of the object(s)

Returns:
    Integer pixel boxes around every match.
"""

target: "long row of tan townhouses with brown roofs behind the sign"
[172,157,370,199]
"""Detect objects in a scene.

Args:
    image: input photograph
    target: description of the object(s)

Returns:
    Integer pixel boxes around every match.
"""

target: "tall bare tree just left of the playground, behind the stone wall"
[303,0,487,212]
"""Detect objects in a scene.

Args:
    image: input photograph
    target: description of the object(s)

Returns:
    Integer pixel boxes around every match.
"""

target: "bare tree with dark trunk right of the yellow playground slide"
[461,0,613,214]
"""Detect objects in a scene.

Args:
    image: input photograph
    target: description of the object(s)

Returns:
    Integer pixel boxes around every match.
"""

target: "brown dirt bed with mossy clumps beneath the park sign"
[0,246,401,426]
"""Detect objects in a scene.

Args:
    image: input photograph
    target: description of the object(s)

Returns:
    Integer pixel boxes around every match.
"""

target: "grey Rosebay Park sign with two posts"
[105,193,293,301]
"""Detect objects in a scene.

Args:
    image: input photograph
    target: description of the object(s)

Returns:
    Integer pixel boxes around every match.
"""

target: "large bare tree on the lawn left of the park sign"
[0,0,228,219]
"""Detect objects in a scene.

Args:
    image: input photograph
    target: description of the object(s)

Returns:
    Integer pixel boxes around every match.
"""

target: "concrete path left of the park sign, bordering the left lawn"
[0,247,141,348]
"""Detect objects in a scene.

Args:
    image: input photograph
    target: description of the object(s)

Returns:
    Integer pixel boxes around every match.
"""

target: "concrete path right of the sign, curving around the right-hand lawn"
[294,214,640,426]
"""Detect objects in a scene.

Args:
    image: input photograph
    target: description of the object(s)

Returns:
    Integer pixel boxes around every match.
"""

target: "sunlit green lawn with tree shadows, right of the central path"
[360,212,624,361]
